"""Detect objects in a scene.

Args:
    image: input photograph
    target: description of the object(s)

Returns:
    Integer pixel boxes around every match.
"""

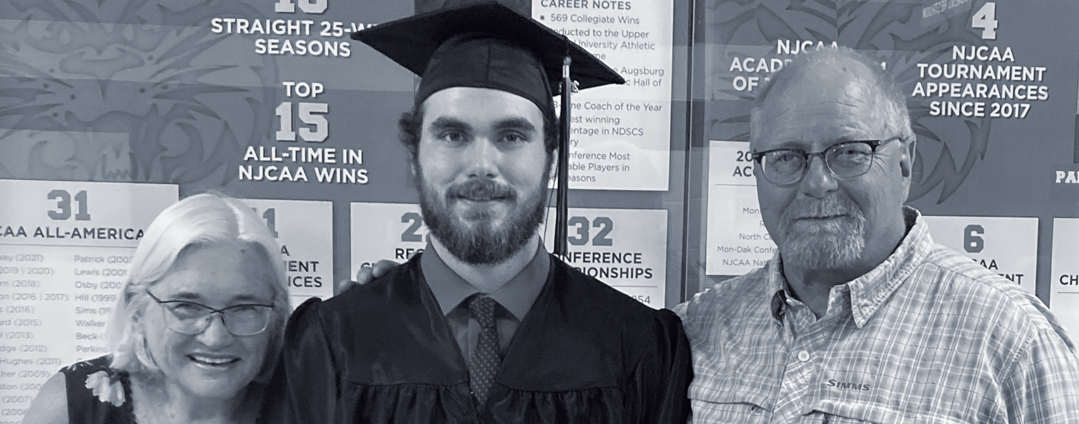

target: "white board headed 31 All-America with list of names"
[0,179,177,416]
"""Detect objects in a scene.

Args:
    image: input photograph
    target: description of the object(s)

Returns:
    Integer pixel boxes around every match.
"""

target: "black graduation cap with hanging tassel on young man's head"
[352,2,626,256]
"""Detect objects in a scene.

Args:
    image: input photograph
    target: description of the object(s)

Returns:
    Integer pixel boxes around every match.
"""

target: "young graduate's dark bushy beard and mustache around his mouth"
[418,173,547,265]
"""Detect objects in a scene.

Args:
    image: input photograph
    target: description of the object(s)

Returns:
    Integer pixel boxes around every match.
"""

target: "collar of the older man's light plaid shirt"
[768,206,933,328]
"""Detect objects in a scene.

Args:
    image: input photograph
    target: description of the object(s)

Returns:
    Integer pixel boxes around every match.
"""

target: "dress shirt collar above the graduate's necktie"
[420,239,550,320]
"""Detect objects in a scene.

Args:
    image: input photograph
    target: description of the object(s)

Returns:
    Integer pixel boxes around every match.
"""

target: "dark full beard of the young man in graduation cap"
[418,172,547,265]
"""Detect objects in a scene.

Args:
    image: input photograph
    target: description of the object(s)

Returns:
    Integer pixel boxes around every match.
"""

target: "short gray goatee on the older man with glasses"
[779,196,865,270]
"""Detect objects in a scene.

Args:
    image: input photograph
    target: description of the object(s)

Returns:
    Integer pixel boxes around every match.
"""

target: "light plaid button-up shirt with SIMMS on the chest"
[675,208,1079,423]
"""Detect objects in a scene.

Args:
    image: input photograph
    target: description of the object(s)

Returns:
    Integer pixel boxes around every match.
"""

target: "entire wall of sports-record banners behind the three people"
[0,0,1079,418]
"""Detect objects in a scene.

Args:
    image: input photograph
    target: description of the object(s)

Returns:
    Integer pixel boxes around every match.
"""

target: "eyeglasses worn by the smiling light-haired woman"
[146,290,273,336]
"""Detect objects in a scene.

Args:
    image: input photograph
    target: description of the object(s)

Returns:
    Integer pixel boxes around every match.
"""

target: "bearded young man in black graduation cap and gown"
[261,4,692,423]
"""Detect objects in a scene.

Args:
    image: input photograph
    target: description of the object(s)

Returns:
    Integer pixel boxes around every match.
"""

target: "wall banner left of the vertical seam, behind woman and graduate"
[0,0,689,416]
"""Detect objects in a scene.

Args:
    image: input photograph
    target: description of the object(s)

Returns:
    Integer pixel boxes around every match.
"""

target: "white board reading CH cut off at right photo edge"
[1049,218,1079,340]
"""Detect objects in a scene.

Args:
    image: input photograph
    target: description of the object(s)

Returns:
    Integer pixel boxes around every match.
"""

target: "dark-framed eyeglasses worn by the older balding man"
[752,137,902,186]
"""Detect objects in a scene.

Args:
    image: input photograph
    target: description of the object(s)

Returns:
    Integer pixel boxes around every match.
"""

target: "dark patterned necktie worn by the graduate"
[468,295,500,410]
